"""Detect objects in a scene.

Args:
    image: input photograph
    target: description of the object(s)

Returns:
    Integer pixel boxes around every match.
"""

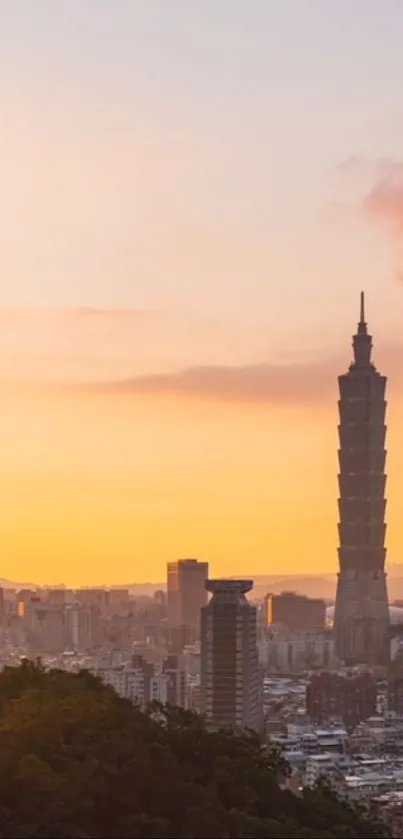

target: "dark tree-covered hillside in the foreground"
[0,662,388,839]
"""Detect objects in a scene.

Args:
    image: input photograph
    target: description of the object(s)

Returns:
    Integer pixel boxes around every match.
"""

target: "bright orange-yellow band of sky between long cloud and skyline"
[0,378,403,584]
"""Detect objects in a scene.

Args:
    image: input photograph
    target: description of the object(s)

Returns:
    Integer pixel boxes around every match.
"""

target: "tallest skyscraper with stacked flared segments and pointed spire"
[334,293,389,664]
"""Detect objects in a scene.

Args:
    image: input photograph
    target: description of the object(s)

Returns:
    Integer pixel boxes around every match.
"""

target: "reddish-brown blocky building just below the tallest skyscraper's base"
[306,672,376,730]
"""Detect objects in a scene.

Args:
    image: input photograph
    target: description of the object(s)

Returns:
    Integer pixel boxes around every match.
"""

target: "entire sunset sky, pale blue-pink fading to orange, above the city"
[0,0,403,585]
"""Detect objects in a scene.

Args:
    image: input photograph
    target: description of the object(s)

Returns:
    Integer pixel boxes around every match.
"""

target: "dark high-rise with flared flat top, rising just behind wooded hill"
[201,580,262,730]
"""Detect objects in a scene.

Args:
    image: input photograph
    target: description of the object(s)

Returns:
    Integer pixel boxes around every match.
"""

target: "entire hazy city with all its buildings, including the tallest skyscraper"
[0,292,403,835]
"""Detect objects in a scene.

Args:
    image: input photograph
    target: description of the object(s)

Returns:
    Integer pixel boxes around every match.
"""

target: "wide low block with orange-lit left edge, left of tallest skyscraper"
[265,591,326,632]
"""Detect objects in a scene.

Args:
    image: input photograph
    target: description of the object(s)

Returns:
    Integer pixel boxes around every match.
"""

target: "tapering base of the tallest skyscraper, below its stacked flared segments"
[334,569,390,665]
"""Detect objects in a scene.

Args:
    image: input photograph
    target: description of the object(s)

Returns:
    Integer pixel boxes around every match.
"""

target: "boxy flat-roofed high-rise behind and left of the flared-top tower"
[167,559,208,640]
